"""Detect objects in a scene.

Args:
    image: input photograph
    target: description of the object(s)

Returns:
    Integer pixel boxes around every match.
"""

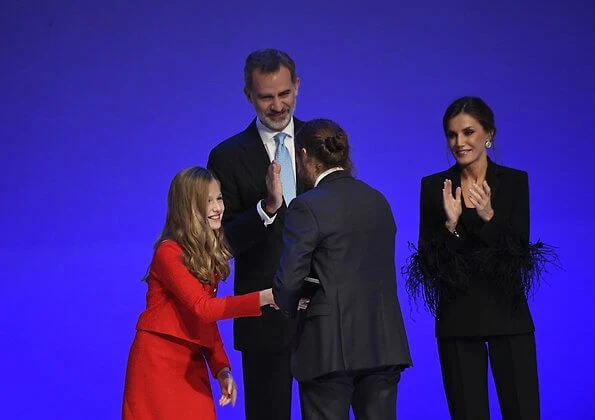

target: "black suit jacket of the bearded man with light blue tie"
[207,118,303,351]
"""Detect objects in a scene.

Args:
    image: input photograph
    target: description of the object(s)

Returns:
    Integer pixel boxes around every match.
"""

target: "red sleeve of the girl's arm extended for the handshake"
[151,241,262,323]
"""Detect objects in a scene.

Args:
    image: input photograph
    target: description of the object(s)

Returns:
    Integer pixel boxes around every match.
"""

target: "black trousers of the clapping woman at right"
[438,334,539,420]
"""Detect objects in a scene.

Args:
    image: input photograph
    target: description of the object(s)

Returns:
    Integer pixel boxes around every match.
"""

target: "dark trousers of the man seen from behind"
[299,366,401,420]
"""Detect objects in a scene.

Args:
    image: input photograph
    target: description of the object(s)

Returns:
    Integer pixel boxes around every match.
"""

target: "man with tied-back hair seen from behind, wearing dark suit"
[273,120,411,420]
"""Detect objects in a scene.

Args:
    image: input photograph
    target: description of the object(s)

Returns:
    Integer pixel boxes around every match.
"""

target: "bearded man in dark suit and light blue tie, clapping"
[208,49,302,420]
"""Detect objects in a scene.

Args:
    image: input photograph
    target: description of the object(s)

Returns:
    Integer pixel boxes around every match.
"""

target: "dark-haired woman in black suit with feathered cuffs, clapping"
[405,97,548,420]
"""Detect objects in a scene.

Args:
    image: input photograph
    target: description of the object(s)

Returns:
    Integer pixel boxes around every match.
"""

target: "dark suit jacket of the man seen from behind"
[273,171,411,380]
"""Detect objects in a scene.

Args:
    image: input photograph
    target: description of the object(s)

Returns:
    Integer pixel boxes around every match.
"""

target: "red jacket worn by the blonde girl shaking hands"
[136,240,262,375]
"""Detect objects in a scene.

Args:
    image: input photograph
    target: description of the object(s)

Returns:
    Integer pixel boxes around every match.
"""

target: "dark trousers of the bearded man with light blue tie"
[242,348,293,420]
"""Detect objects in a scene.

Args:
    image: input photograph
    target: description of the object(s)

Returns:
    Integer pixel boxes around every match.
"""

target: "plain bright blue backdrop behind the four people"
[0,0,595,419]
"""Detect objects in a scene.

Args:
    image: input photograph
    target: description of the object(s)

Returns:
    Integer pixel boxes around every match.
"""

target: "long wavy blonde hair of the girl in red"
[155,166,231,284]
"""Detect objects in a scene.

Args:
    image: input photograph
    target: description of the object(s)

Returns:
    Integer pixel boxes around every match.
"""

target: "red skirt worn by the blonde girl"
[122,331,215,420]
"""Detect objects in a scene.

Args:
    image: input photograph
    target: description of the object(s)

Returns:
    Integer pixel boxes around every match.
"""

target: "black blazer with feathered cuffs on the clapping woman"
[419,160,534,338]
